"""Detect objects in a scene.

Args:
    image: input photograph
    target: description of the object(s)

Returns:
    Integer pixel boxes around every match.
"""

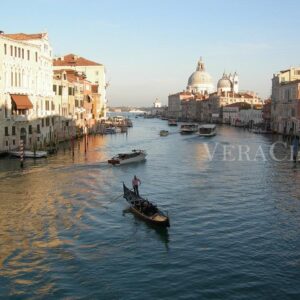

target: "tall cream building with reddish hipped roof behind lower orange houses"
[53,54,107,120]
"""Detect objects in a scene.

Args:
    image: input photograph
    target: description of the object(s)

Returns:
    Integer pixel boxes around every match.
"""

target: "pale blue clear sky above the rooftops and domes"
[0,0,300,107]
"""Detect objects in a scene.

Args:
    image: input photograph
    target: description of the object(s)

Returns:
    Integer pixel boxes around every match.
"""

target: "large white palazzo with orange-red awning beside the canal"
[0,33,55,151]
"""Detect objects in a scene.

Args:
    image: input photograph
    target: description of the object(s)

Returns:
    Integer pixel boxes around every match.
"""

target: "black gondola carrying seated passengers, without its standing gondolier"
[123,183,170,227]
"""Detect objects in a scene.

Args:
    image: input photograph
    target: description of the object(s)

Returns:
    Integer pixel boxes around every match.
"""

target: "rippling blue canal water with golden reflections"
[0,118,300,299]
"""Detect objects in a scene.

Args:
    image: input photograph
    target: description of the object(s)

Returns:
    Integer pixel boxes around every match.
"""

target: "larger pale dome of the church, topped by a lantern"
[187,58,214,95]
